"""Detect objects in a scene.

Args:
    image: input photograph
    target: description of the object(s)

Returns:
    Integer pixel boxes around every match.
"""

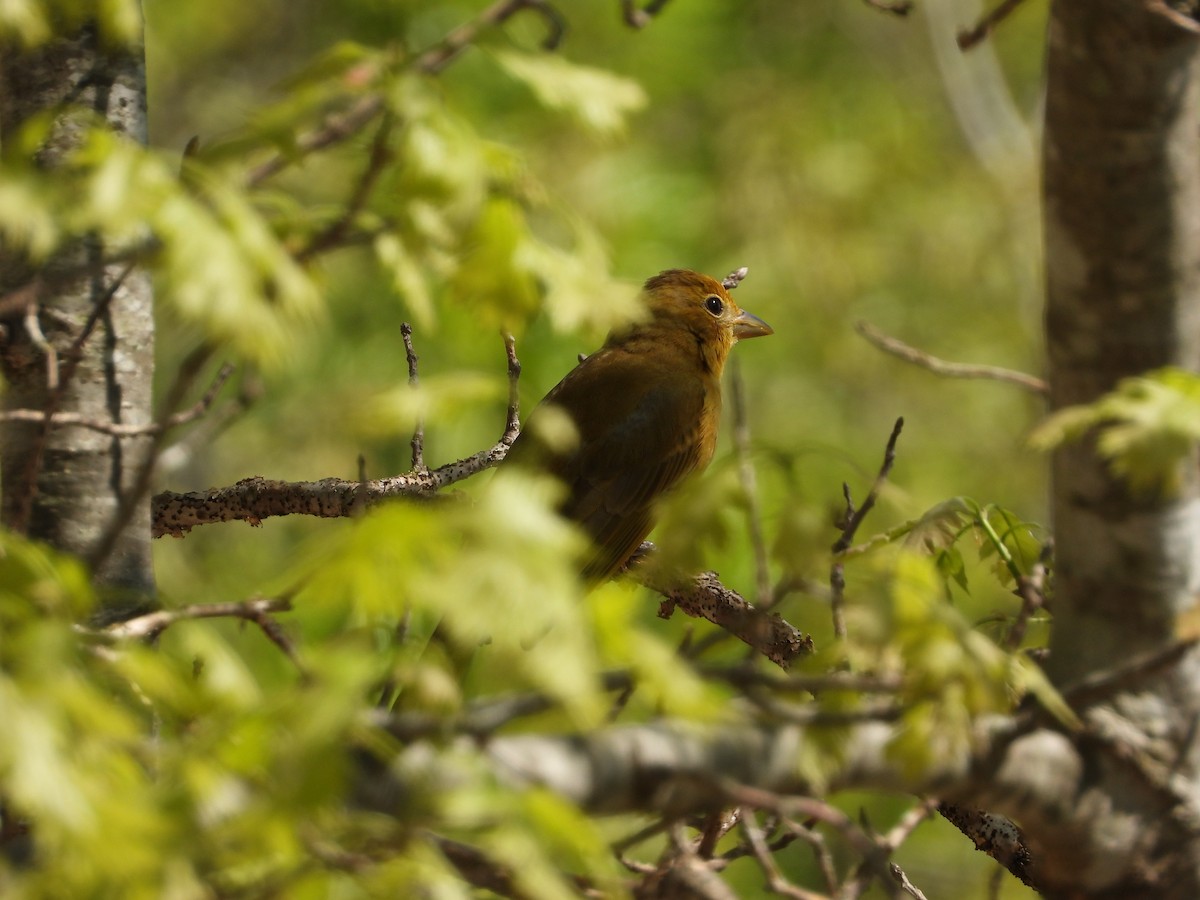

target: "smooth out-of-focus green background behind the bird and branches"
[144,0,1045,898]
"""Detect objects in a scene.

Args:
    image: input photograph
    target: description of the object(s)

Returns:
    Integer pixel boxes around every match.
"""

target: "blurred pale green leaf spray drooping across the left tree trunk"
[0,118,317,364]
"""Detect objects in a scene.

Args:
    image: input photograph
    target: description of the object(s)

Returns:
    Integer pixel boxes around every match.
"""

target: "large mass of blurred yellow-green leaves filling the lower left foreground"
[0,489,643,898]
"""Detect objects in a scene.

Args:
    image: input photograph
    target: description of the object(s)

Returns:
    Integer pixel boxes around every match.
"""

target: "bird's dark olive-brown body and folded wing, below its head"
[546,354,715,578]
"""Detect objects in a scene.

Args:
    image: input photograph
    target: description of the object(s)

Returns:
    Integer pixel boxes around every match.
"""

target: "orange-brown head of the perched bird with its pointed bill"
[644,269,774,376]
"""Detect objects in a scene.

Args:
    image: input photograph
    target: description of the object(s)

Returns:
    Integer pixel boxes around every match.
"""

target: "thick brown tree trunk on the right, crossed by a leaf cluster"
[1036,0,1200,899]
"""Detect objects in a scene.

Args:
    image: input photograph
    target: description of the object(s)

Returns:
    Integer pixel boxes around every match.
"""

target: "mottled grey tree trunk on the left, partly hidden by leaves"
[0,26,154,620]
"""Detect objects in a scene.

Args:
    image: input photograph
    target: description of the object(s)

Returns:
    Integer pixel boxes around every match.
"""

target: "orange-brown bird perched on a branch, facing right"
[505,269,773,582]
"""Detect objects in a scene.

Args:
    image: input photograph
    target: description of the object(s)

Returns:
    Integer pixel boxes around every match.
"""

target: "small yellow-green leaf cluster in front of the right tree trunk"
[1030,368,1200,496]
